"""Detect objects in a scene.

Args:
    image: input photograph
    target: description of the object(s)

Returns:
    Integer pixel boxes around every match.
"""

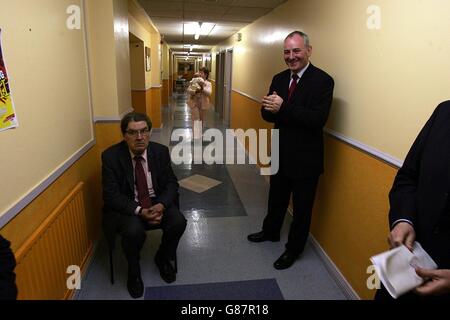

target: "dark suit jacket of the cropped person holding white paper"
[389,101,450,270]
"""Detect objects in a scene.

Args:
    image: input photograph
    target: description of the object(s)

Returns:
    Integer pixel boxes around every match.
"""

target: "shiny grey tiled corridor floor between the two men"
[77,95,345,300]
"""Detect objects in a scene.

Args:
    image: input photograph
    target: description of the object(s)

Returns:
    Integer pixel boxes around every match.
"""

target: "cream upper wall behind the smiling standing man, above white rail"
[215,0,450,160]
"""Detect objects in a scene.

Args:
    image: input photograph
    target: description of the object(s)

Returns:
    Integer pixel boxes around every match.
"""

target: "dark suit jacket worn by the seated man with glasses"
[102,141,179,247]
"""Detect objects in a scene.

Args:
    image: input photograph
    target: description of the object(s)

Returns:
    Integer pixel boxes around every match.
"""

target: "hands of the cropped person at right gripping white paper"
[388,222,450,296]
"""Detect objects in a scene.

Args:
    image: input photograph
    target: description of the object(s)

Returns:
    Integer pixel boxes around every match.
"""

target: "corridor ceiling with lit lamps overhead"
[138,0,287,52]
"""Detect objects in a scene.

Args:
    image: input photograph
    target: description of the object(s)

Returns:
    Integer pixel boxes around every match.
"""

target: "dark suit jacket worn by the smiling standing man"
[261,63,334,178]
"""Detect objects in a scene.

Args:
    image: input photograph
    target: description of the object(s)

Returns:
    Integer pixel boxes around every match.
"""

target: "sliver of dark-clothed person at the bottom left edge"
[0,235,17,300]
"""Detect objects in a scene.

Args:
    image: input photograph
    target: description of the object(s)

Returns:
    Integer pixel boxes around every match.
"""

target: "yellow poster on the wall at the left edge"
[0,29,19,131]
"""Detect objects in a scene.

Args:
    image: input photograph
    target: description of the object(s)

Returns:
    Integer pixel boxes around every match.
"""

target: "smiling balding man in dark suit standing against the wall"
[248,31,334,270]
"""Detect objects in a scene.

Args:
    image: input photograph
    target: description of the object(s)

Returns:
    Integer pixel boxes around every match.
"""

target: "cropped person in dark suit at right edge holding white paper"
[376,101,450,299]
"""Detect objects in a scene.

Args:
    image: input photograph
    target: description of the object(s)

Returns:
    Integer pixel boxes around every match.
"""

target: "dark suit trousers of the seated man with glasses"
[117,205,186,274]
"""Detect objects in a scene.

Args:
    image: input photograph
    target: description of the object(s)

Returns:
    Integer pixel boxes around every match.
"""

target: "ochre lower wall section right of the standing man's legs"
[311,135,397,299]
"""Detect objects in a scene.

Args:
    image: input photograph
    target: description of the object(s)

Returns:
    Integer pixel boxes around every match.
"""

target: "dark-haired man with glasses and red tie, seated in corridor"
[102,112,186,298]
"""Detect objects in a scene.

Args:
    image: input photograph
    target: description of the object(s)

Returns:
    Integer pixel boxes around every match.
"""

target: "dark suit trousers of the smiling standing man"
[263,170,319,255]
